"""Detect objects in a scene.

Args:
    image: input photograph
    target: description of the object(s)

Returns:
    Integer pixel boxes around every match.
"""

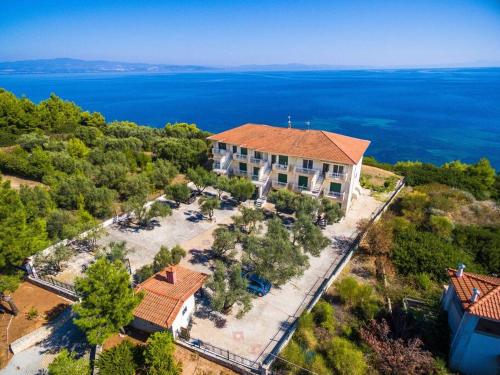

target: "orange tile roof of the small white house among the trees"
[134,265,208,328]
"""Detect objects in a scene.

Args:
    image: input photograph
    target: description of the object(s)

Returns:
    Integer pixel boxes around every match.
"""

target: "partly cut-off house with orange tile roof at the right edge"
[442,265,500,375]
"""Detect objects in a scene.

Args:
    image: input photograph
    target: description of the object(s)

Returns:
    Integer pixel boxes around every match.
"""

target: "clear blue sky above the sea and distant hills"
[0,0,500,67]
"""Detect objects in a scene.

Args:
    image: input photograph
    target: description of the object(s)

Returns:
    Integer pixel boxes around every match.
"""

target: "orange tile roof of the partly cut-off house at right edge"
[448,269,500,320]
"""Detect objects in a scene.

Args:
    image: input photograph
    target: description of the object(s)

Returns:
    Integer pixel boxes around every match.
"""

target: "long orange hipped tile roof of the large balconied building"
[208,124,370,164]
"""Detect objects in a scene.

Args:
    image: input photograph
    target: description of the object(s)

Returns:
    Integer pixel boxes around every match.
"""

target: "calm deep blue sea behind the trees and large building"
[0,68,500,170]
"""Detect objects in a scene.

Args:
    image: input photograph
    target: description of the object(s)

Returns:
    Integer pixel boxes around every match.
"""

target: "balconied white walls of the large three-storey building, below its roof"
[212,142,362,211]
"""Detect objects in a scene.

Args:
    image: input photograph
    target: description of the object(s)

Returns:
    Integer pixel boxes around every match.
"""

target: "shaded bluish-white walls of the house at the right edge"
[442,285,500,375]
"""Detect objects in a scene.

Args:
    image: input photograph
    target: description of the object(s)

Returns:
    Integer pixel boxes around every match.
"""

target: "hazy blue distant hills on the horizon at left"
[0,58,213,74]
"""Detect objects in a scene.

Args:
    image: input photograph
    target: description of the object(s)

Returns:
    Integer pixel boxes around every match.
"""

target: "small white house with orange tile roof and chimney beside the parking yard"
[131,265,208,336]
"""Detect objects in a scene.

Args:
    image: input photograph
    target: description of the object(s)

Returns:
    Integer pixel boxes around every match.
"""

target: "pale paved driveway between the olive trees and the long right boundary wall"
[187,190,382,361]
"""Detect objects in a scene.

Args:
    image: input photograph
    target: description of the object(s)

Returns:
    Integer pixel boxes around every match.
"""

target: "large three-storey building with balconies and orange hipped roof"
[208,124,370,211]
